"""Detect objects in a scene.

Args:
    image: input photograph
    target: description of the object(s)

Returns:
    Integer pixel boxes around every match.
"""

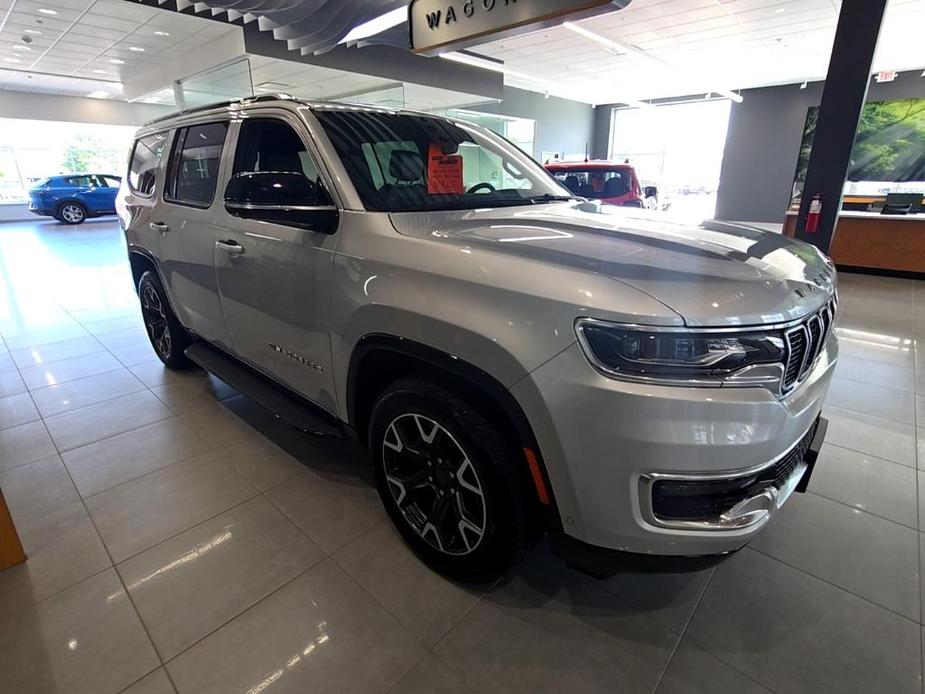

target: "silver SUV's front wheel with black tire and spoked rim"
[369,378,530,581]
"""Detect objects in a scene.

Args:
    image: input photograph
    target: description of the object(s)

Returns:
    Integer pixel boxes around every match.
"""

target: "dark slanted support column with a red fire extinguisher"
[796,0,887,252]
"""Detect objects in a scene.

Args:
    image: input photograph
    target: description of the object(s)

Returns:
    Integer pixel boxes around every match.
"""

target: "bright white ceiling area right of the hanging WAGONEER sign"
[472,0,925,103]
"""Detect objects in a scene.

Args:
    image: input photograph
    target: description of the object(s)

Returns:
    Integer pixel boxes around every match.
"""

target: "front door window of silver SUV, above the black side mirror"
[232,118,331,205]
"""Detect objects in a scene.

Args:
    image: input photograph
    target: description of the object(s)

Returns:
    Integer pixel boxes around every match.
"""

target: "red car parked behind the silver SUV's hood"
[545,161,656,207]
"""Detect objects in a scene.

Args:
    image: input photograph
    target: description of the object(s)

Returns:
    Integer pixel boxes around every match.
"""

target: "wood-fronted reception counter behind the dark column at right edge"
[784,210,925,274]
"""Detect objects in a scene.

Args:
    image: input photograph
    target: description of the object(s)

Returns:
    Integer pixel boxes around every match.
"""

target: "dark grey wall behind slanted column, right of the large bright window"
[716,71,925,222]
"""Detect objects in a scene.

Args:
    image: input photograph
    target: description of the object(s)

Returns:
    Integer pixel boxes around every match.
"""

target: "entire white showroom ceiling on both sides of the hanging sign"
[0,0,925,108]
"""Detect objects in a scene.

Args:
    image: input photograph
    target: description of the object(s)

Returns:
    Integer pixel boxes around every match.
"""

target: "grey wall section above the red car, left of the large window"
[473,87,595,159]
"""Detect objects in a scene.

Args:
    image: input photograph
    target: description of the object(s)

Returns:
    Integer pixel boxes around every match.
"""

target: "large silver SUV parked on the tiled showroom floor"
[118,97,837,578]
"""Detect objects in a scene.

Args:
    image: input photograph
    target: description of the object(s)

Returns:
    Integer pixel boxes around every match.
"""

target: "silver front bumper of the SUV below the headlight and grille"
[512,335,838,557]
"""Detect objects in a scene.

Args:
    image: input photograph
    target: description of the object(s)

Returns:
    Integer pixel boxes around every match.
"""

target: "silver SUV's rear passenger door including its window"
[150,121,229,347]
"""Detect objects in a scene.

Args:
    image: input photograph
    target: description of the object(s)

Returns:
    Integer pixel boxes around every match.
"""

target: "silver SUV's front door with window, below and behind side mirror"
[215,112,336,411]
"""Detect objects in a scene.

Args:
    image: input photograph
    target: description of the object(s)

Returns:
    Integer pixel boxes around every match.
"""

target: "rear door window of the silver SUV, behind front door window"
[164,122,228,207]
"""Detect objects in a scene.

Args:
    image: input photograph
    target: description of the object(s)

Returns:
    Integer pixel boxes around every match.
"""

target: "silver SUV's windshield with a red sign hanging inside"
[315,110,570,212]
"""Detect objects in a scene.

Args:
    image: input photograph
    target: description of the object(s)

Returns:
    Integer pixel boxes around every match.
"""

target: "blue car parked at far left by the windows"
[29,174,122,224]
